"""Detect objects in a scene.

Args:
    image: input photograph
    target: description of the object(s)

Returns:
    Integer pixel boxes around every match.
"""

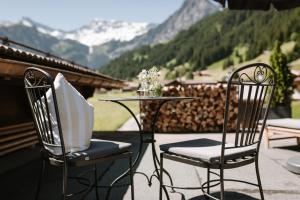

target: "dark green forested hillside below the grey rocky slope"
[100,8,300,79]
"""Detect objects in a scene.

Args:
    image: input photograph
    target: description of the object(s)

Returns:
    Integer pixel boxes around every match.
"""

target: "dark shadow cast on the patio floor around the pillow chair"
[0,133,147,200]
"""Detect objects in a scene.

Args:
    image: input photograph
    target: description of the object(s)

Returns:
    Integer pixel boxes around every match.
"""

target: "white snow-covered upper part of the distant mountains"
[8,18,154,47]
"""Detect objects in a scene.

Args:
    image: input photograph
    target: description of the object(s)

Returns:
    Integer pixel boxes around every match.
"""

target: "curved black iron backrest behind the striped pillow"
[24,67,65,157]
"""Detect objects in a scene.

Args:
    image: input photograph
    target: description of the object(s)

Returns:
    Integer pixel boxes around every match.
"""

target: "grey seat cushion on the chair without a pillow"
[160,138,256,163]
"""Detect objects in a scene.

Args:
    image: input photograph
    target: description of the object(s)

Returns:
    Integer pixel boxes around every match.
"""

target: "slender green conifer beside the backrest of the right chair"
[270,41,293,107]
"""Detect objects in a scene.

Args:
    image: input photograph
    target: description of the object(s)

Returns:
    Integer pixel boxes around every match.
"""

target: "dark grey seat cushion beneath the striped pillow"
[67,139,131,161]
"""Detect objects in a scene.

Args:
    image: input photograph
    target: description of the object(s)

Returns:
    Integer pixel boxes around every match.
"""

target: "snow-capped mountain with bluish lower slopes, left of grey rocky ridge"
[0,17,154,68]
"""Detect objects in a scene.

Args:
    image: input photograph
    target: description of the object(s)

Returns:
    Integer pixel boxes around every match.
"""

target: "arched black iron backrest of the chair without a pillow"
[222,63,276,156]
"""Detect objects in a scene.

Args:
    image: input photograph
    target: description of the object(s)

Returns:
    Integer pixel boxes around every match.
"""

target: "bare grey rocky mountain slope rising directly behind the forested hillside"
[101,0,222,58]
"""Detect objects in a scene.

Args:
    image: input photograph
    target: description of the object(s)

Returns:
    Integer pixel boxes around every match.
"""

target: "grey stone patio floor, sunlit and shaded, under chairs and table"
[0,133,300,200]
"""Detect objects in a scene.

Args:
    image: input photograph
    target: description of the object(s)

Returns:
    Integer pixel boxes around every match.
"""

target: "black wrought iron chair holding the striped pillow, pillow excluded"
[24,67,134,199]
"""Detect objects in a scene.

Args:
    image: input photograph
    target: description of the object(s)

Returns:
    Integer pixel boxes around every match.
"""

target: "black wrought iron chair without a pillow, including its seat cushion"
[159,63,276,200]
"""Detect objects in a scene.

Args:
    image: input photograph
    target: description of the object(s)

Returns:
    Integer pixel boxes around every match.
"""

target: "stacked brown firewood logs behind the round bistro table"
[140,84,238,132]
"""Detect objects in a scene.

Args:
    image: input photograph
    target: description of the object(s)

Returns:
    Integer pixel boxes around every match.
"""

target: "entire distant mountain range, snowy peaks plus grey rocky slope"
[0,0,219,68]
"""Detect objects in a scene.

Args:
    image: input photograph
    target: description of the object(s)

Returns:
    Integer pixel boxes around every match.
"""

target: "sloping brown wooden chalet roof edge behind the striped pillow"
[0,44,125,89]
